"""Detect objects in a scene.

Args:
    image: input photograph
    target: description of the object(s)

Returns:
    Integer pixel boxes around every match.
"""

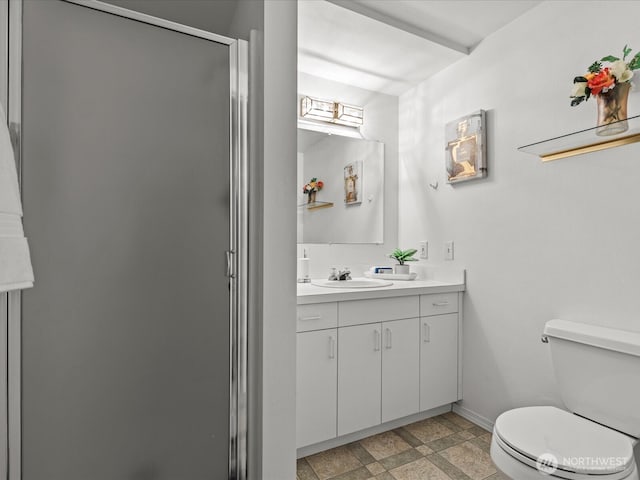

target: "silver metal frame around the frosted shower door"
[0,0,249,480]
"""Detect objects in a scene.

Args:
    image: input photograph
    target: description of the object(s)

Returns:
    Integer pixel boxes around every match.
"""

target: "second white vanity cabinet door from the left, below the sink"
[338,323,382,435]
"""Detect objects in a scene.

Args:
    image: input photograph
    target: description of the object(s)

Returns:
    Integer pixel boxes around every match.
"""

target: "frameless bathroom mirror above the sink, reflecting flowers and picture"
[298,128,384,244]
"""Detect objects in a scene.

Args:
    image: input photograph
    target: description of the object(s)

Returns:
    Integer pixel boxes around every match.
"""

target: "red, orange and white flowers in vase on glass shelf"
[571,45,640,107]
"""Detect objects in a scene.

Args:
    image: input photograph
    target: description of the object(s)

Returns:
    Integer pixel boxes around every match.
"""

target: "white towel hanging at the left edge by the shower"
[0,106,33,292]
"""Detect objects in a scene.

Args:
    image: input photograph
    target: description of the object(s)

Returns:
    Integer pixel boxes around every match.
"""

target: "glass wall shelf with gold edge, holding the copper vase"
[518,115,640,162]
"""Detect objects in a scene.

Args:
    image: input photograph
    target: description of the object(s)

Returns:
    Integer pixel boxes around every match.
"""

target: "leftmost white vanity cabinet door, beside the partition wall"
[296,328,338,447]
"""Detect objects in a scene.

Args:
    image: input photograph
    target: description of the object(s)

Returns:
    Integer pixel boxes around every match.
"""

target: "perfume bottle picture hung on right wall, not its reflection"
[445,110,487,183]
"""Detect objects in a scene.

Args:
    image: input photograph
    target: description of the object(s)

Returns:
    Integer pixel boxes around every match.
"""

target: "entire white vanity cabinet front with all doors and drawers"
[296,290,460,448]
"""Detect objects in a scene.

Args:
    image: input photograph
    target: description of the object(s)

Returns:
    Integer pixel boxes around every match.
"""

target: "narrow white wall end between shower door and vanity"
[262,0,298,480]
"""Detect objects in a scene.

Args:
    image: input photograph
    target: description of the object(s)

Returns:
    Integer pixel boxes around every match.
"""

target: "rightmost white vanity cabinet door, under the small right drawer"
[420,313,458,410]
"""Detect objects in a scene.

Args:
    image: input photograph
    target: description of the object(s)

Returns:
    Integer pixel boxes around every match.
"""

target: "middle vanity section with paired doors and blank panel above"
[338,295,420,435]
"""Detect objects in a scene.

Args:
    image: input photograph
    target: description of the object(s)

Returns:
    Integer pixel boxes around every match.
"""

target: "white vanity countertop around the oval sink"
[298,277,465,305]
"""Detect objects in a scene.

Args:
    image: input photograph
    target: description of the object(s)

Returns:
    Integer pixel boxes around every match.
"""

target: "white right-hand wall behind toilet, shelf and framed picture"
[399,1,640,428]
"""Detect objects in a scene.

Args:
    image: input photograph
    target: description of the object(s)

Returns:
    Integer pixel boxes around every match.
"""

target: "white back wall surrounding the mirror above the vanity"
[296,73,404,278]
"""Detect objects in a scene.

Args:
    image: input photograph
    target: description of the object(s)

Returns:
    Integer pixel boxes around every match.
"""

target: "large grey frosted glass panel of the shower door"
[22,0,238,480]
